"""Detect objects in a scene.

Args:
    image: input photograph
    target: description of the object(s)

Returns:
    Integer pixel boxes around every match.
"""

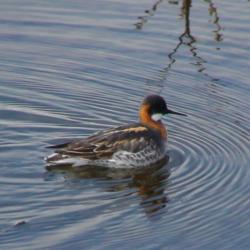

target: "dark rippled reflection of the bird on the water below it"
[45,156,170,216]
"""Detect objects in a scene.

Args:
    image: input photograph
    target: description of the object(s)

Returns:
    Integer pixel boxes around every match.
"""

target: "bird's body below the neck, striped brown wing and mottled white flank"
[47,123,166,167]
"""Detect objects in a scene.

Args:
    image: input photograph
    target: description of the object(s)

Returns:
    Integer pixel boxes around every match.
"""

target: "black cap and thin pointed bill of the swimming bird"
[143,95,186,116]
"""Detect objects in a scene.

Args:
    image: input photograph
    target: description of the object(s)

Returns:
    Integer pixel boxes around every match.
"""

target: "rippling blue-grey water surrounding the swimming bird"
[0,0,250,250]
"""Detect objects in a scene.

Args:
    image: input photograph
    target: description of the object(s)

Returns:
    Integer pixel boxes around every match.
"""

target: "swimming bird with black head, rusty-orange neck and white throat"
[46,95,185,168]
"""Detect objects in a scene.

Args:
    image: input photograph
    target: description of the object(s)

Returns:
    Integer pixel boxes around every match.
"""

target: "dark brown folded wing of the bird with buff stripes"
[51,124,160,160]
